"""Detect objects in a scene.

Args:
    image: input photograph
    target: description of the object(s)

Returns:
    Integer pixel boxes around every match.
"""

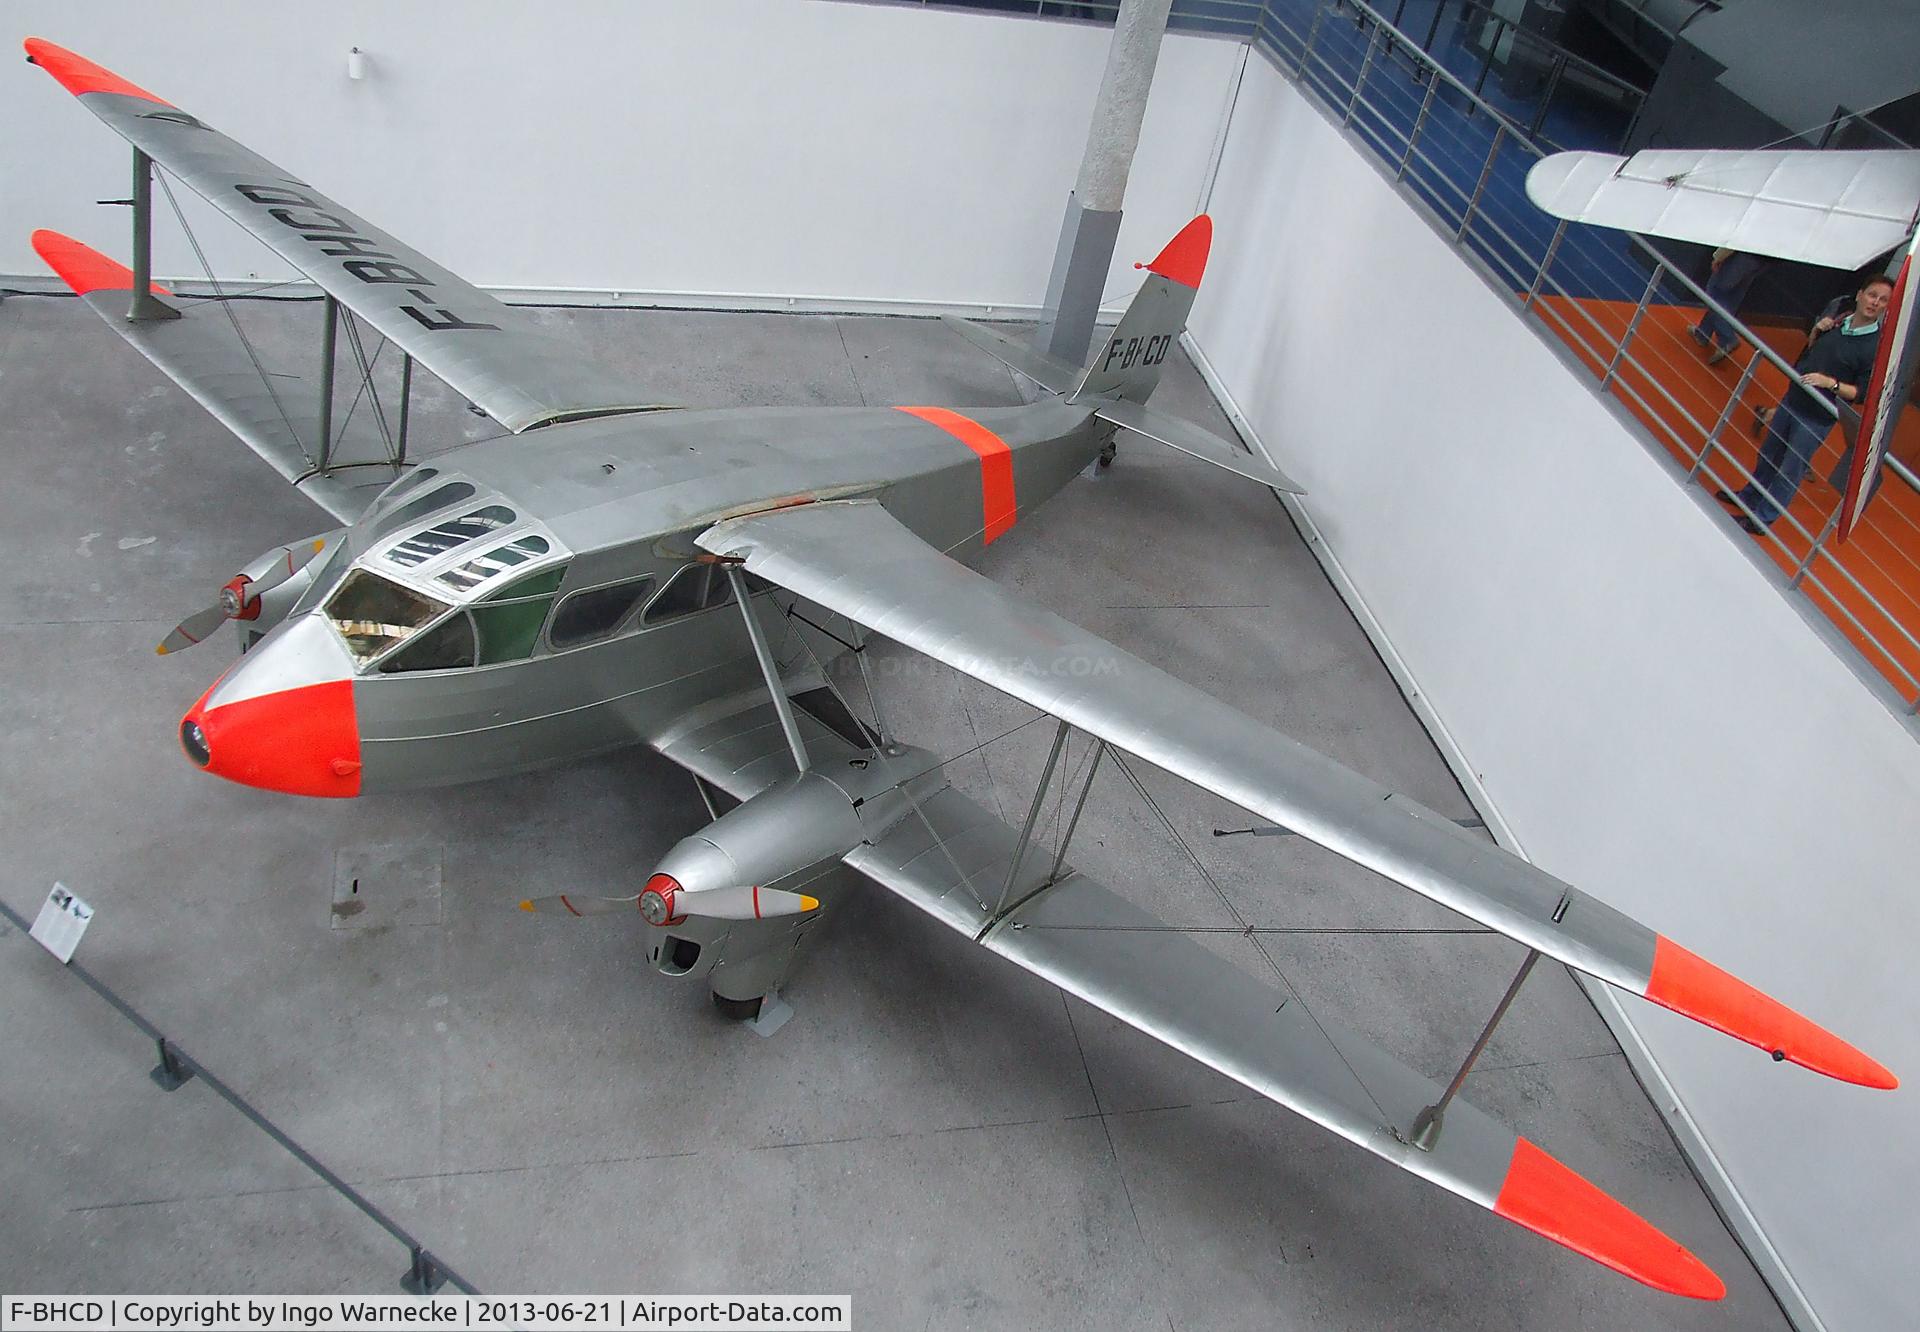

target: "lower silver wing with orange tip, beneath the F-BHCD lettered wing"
[33,230,399,522]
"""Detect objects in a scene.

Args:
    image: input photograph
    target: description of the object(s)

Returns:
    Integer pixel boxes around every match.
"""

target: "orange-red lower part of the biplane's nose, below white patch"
[180,679,361,797]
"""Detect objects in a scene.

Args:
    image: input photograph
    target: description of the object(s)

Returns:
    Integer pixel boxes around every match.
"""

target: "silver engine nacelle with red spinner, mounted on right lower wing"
[639,745,941,925]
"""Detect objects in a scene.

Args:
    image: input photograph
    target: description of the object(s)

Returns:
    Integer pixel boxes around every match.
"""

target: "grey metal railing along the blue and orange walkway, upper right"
[1254,0,1920,712]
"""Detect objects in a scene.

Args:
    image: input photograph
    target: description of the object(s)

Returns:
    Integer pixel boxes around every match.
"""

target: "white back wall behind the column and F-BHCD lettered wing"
[0,0,1240,307]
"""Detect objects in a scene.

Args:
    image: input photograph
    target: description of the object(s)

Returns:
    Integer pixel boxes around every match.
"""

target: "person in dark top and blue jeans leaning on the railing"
[1715,276,1893,534]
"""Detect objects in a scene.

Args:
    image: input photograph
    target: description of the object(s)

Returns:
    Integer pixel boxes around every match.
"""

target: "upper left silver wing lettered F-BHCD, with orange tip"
[27,36,651,432]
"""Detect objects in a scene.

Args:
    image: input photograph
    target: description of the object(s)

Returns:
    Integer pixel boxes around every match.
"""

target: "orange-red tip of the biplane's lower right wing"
[1494,1138,1726,1299]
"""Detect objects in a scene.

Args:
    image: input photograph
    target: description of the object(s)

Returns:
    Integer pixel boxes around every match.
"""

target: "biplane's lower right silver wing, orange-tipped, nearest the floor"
[655,694,1726,1299]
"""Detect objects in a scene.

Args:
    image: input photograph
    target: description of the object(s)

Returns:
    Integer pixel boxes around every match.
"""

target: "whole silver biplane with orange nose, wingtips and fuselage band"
[27,38,1895,1299]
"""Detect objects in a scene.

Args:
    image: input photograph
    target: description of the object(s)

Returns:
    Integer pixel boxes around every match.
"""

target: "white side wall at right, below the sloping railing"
[1192,59,1920,1332]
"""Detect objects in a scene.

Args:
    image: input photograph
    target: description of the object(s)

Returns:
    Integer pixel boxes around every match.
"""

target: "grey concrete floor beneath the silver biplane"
[0,297,1786,1332]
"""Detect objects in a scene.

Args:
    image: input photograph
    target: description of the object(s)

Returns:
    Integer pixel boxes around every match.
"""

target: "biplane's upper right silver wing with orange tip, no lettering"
[697,501,1897,1086]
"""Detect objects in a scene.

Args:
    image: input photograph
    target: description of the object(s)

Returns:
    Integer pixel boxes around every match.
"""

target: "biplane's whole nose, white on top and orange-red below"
[180,616,361,797]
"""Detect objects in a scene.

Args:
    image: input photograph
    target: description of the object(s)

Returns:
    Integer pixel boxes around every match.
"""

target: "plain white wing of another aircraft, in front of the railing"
[1526,148,1920,269]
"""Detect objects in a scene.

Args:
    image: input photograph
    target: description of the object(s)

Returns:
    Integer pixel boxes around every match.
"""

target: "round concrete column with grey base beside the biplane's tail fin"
[1033,0,1173,365]
